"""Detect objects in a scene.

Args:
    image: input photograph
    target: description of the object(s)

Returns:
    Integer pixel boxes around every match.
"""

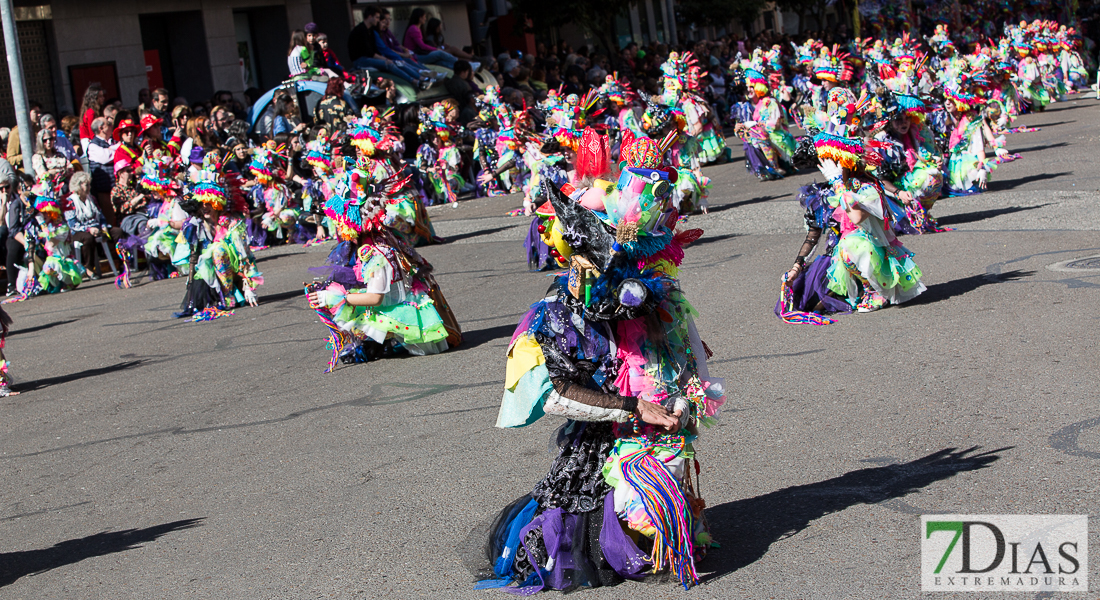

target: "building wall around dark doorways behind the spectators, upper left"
[52,0,312,110]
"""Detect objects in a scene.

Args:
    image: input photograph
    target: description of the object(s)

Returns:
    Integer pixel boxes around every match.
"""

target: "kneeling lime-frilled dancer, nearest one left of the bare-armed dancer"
[176,152,264,318]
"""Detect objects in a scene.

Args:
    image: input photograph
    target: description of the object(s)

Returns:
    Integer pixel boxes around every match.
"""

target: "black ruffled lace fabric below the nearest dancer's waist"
[531,422,615,514]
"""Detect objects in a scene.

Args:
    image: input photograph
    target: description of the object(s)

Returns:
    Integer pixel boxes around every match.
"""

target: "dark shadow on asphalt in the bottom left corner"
[0,519,202,587]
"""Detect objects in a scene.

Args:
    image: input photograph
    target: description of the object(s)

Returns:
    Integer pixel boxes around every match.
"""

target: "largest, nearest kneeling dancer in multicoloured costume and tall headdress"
[468,133,725,596]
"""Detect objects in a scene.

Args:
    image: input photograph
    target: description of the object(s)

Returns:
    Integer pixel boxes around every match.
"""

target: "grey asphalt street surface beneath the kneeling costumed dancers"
[0,96,1100,600]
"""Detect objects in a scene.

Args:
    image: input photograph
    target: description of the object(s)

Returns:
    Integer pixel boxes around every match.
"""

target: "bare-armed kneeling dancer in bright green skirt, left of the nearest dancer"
[306,165,462,372]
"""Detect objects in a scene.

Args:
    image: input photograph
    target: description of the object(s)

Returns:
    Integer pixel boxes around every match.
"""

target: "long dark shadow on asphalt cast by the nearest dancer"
[701,446,1011,581]
